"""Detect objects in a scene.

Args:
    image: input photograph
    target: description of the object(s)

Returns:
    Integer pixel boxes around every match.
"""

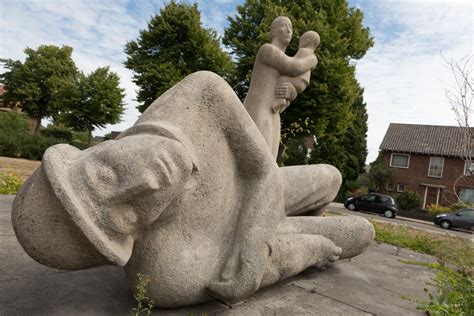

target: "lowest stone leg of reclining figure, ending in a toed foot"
[260,234,341,288]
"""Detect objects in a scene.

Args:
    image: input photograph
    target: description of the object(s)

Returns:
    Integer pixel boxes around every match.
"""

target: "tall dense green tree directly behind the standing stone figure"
[223,0,373,175]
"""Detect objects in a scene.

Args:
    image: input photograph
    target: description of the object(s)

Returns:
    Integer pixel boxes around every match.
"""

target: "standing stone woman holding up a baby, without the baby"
[244,16,317,159]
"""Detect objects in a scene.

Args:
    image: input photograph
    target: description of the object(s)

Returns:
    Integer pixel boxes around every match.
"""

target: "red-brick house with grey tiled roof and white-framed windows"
[380,123,474,209]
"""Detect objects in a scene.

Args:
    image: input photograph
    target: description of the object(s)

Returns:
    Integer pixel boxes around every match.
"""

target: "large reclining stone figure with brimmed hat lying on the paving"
[12,16,374,307]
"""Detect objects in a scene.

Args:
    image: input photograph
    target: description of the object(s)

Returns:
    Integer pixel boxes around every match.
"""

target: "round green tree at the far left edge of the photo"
[0,45,77,133]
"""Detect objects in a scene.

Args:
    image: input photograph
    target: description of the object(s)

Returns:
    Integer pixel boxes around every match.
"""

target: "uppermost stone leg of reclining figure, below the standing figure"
[280,164,342,216]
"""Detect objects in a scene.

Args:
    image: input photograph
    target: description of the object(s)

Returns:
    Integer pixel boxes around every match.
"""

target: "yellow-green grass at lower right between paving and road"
[372,221,474,315]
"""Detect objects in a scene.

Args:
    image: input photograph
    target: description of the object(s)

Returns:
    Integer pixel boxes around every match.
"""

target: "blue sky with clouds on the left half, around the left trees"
[0,0,235,135]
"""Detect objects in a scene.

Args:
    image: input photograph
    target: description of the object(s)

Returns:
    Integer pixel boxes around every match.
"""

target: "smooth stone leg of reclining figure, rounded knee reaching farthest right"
[279,216,375,259]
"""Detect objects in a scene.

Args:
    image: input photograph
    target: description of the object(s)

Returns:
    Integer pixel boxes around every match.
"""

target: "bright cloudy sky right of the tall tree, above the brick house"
[357,1,474,162]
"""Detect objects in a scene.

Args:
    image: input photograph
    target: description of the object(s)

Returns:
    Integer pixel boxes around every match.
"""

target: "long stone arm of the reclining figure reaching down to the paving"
[209,120,284,302]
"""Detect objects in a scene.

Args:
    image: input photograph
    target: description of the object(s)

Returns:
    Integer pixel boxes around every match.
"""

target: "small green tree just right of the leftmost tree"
[58,67,125,145]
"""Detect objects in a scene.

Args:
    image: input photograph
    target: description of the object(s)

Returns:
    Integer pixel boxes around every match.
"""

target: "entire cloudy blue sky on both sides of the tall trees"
[0,0,474,162]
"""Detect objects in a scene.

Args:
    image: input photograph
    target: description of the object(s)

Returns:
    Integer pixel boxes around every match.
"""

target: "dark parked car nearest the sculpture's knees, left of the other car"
[344,193,398,218]
